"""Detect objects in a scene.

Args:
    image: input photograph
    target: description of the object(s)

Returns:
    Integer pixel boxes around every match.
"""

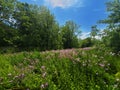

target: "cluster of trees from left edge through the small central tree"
[0,0,79,51]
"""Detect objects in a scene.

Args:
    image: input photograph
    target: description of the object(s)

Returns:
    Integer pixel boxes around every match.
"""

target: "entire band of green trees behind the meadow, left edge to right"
[0,0,120,53]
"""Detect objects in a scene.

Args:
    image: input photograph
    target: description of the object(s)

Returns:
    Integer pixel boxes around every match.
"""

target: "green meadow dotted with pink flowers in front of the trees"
[0,48,120,90]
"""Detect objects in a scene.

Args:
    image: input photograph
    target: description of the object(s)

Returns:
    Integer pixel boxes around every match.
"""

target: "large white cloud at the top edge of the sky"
[44,0,83,8]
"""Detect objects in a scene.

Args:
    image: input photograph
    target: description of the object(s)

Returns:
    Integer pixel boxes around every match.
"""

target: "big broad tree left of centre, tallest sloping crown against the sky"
[14,3,61,50]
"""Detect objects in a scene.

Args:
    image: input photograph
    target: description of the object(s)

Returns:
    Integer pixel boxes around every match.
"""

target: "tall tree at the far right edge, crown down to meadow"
[100,0,120,53]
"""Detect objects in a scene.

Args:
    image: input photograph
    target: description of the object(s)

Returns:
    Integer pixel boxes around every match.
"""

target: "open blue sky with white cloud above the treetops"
[19,0,109,38]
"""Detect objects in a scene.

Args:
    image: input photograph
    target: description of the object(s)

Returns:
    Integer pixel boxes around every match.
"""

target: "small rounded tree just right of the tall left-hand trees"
[62,21,79,48]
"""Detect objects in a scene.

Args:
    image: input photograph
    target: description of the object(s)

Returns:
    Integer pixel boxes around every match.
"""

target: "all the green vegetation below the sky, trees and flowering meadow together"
[0,0,120,90]
